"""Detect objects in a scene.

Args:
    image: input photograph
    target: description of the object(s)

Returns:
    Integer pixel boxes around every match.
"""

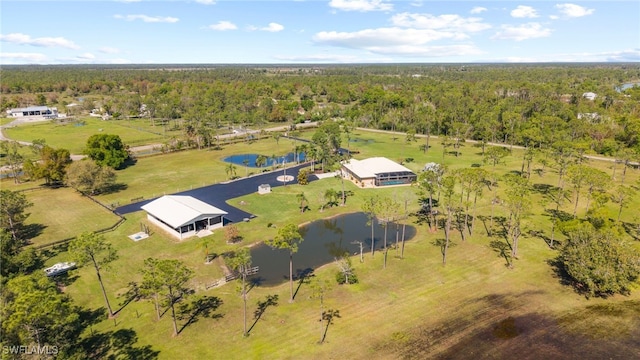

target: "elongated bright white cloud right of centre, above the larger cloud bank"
[391,13,491,32]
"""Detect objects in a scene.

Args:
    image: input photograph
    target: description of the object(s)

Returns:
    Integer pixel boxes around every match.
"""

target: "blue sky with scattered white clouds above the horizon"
[0,0,640,65]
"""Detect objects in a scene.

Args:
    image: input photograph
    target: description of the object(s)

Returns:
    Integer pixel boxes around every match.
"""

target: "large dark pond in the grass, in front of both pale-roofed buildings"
[251,213,416,286]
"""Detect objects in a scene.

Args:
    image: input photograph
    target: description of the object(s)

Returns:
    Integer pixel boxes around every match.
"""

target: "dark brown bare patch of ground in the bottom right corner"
[376,295,640,359]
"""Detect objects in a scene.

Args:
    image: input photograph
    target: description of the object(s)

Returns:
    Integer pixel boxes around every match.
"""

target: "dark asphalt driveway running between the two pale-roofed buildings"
[115,164,318,222]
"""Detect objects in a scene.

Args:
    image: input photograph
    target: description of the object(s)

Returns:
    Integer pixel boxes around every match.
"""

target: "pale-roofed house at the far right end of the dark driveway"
[340,157,417,187]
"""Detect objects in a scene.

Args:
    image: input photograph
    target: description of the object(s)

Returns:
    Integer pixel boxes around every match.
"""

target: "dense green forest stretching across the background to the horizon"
[0,64,640,155]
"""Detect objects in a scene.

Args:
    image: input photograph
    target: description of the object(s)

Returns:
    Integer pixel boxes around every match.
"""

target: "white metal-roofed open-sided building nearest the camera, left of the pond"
[142,195,227,240]
